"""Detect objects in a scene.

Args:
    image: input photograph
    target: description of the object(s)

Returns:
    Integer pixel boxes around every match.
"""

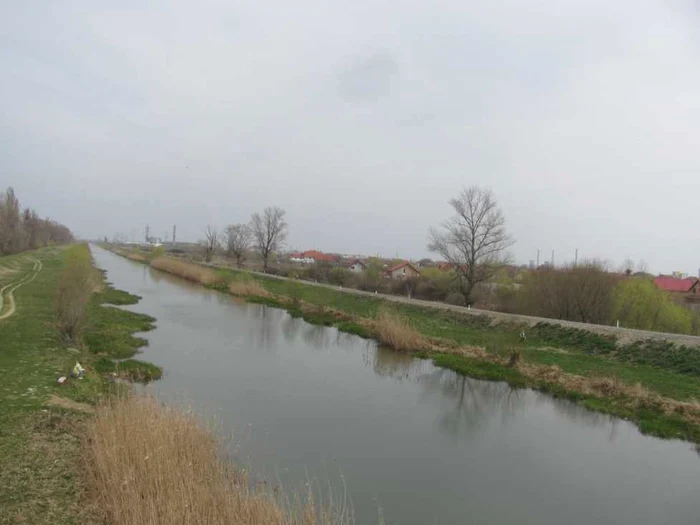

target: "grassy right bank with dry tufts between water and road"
[130,252,700,442]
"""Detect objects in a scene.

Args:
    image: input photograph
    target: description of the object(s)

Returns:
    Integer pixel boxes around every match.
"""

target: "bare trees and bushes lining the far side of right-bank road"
[189,186,700,334]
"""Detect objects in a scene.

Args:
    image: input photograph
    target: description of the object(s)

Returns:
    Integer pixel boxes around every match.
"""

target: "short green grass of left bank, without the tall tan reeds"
[0,246,159,524]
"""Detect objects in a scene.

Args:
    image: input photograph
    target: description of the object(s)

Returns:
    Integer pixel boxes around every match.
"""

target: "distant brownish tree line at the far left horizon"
[0,187,74,255]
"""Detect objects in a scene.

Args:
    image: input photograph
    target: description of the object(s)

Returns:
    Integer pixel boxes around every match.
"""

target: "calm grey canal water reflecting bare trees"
[92,247,700,525]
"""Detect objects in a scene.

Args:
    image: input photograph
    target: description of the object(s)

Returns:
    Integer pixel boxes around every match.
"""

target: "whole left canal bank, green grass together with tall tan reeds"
[0,246,356,525]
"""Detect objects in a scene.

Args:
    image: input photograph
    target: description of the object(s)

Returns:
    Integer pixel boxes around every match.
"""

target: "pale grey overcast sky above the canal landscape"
[0,0,700,274]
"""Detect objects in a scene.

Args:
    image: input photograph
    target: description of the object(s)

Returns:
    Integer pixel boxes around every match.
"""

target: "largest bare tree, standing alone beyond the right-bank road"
[428,186,515,304]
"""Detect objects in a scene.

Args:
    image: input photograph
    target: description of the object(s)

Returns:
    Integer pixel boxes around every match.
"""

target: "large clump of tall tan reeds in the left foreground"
[85,397,350,525]
